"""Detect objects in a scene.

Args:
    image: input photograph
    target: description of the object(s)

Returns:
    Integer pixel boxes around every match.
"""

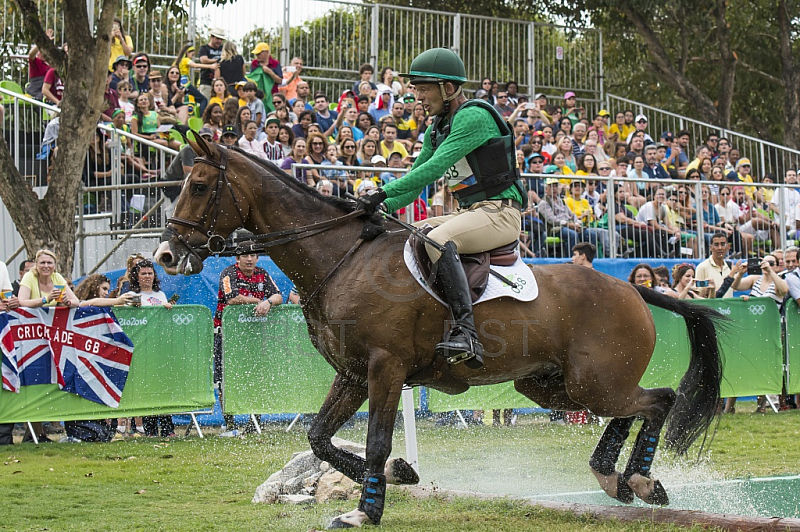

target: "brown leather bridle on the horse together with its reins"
[166,148,364,301]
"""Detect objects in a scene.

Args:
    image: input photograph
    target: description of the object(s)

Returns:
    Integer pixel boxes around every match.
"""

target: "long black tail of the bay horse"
[636,285,726,455]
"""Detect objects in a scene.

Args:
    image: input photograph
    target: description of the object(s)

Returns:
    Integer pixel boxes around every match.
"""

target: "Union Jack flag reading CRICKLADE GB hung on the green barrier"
[0,307,133,408]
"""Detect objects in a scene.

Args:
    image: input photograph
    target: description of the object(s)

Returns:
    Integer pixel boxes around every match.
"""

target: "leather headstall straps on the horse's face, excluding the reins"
[166,149,244,262]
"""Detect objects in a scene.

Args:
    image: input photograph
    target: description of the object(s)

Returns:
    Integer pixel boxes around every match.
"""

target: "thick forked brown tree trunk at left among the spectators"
[0,0,116,276]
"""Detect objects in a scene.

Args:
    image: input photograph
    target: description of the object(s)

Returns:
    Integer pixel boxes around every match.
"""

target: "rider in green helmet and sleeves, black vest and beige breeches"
[358,48,527,369]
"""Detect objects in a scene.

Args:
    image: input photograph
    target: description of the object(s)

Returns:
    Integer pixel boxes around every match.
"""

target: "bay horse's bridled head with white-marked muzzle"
[155,135,251,275]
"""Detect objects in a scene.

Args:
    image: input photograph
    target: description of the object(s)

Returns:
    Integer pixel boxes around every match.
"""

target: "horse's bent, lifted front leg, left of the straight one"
[308,375,367,482]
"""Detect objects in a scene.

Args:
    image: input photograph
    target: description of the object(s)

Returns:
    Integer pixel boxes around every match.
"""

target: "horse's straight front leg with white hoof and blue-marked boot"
[329,349,407,528]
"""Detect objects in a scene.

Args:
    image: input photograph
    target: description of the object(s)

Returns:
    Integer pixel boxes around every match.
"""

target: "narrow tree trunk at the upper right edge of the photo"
[777,0,800,149]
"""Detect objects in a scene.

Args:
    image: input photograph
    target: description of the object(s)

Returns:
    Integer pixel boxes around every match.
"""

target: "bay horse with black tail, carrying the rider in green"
[155,137,723,528]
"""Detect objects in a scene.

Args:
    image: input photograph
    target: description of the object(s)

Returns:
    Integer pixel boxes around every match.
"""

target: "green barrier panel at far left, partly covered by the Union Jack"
[0,305,214,423]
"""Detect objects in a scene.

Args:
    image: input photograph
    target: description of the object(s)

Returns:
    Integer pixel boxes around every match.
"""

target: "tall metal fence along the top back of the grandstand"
[0,0,603,101]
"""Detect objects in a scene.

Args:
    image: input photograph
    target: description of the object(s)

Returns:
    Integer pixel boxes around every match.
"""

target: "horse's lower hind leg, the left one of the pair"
[589,417,634,504]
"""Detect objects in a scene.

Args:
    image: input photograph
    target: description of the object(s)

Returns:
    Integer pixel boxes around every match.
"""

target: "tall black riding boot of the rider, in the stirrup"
[436,241,483,369]
